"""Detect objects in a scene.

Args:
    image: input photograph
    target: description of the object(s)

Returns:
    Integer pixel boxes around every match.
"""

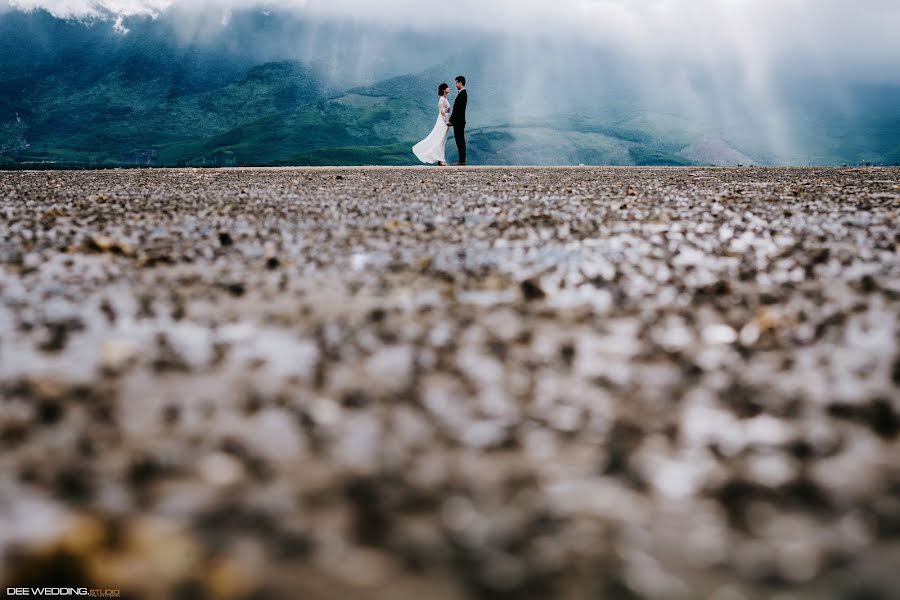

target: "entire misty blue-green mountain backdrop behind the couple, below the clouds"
[0,10,900,167]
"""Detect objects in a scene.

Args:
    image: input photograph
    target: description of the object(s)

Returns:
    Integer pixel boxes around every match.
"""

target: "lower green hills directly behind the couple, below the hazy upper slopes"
[0,54,720,166]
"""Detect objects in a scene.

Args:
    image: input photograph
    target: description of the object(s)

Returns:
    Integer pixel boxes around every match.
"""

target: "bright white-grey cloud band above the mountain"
[7,0,900,79]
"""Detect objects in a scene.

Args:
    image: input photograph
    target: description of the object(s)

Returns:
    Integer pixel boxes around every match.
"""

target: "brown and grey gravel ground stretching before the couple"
[0,168,900,600]
